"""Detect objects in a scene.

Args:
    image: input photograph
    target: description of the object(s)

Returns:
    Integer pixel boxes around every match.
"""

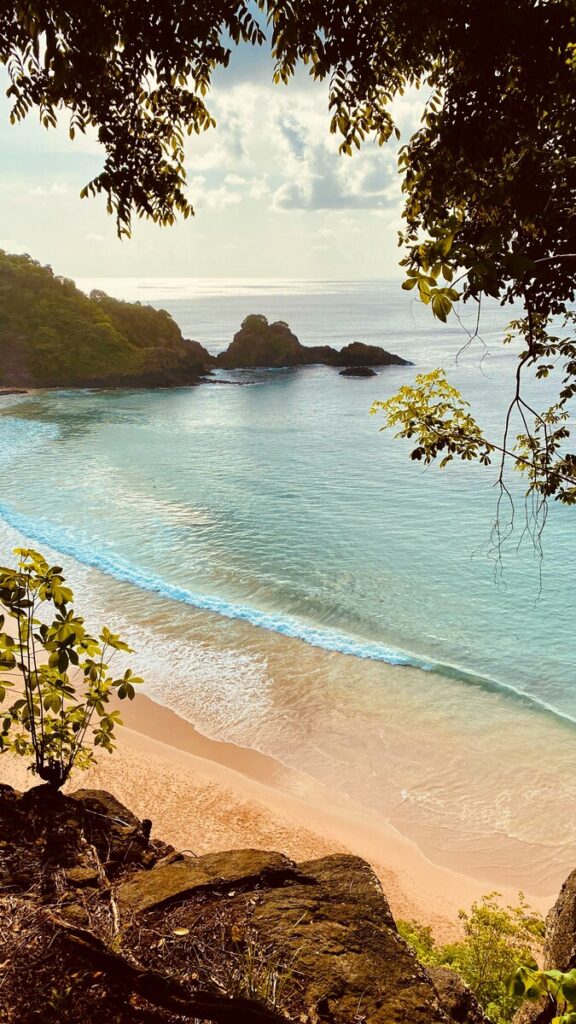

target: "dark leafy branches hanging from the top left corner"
[0,0,262,238]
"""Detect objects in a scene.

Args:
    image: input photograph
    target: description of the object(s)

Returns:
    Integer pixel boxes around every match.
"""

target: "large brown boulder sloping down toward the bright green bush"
[252,855,447,1024]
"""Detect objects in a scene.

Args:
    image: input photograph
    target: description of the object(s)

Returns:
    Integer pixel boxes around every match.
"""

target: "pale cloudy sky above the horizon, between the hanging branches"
[0,40,420,280]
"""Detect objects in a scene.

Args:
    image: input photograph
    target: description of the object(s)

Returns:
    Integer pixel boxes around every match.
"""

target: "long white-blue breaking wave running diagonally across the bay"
[0,504,576,725]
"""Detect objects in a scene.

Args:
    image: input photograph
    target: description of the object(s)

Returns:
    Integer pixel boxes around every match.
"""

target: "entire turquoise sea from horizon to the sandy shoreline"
[0,279,576,887]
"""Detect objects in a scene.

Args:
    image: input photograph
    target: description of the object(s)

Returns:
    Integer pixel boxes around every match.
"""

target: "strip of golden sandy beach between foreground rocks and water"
[0,694,556,940]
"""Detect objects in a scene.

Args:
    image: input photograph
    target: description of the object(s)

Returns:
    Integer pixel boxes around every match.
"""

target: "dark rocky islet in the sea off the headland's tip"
[216,313,409,370]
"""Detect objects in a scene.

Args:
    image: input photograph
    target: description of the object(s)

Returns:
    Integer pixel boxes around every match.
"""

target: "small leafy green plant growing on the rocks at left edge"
[0,548,142,790]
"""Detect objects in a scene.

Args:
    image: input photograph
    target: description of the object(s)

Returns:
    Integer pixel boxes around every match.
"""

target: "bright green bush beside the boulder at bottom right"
[398,893,544,1024]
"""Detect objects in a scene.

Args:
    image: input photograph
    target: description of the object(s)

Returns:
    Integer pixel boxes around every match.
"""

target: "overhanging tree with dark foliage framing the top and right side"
[0,0,576,514]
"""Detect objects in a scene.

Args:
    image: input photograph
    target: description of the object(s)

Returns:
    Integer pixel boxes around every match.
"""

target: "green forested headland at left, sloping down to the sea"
[0,250,207,387]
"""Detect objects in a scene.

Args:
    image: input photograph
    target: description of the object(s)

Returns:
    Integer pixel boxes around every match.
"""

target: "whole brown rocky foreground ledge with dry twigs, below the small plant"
[0,785,483,1024]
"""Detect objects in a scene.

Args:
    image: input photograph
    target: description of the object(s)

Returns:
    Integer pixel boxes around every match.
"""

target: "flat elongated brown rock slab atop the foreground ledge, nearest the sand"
[117,850,297,914]
